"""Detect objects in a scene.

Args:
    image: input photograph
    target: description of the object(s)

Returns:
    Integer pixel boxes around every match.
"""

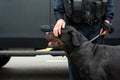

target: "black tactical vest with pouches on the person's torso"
[63,0,108,24]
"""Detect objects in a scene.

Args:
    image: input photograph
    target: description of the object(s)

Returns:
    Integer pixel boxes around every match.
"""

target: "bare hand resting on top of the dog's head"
[53,19,66,37]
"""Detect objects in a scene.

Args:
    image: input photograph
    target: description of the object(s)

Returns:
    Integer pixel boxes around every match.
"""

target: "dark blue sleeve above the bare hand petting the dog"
[54,0,64,20]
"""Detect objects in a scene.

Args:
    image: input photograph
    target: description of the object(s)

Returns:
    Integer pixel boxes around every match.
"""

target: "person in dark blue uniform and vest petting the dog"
[53,0,114,80]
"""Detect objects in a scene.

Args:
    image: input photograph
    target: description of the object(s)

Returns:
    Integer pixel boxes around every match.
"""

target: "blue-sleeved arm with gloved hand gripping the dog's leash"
[100,0,114,35]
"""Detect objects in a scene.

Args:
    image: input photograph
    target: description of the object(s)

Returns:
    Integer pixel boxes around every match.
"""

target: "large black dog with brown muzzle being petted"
[46,26,120,80]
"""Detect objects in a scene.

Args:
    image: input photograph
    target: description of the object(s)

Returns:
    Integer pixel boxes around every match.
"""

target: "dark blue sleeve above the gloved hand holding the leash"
[105,0,114,21]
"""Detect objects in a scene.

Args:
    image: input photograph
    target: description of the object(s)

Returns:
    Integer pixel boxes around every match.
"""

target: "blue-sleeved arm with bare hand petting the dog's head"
[53,0,66,37]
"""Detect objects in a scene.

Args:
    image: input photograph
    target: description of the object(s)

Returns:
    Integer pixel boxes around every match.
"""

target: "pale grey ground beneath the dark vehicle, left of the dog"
[0,55,68,80]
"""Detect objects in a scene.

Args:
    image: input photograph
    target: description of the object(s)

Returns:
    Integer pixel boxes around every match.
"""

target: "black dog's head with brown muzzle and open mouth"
[46,26,87,49]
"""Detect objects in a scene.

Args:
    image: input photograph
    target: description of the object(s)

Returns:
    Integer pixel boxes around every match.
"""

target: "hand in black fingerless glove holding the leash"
[100,20,112,35]
